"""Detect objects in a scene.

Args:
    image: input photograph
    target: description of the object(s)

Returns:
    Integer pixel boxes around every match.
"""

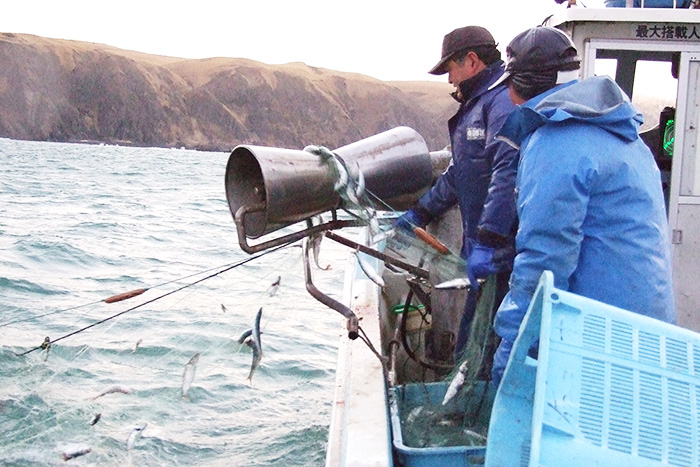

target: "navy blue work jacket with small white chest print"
[419,61,518,260]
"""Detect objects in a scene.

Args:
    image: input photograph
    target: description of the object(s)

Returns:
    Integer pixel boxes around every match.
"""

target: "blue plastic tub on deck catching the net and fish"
[390,381,494,467]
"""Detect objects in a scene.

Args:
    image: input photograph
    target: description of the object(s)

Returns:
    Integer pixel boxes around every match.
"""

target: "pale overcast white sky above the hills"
[0,0,603,80]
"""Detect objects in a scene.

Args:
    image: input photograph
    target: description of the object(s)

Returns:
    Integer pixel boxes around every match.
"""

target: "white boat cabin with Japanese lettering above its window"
[547,4,700,331]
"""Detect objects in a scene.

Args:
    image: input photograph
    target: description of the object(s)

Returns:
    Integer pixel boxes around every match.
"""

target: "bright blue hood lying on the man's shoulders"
[496,76,643,149]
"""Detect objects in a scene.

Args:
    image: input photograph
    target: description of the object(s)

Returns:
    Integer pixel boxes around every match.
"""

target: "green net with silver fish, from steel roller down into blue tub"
[322,150,496,447]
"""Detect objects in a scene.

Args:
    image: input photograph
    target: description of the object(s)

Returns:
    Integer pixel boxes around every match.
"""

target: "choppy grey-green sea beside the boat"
[0,139,348,466]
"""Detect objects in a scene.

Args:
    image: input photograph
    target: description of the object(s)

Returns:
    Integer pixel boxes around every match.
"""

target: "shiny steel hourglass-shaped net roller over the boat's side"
[225,127,432,238]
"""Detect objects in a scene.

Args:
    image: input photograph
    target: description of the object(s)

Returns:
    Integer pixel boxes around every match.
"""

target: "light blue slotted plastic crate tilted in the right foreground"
[486,272,700,467]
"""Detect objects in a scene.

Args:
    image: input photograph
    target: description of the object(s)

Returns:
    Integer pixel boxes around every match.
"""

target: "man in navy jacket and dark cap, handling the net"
[396,26,518,366]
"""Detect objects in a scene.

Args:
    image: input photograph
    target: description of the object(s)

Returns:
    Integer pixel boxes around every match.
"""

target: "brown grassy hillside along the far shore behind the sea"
[0,34,456,151]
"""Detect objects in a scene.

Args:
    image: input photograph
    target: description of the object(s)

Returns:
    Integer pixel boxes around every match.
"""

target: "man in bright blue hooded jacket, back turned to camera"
[492,27,675,383]
